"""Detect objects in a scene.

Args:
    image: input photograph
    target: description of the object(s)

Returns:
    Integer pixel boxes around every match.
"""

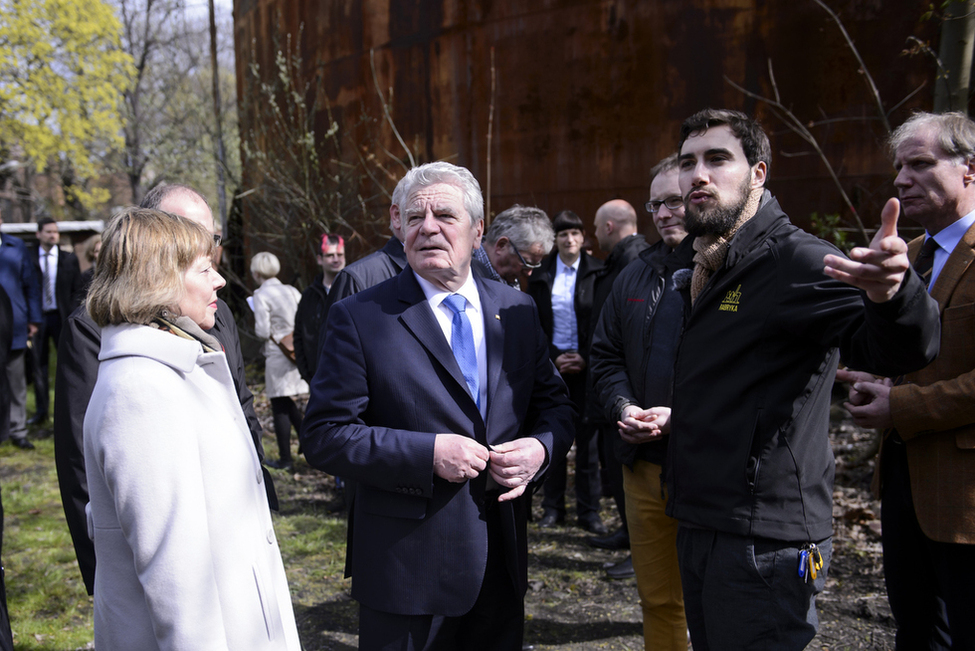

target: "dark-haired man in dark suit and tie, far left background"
[27,217,84,425]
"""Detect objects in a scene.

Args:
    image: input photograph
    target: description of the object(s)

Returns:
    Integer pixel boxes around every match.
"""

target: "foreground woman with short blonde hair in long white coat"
[84,208,301,651]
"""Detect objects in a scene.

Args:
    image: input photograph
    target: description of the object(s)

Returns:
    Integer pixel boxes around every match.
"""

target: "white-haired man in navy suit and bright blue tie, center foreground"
[301,163,573,650]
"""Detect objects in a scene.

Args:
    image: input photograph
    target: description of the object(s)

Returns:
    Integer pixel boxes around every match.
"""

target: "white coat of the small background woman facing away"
[254,278,308,398]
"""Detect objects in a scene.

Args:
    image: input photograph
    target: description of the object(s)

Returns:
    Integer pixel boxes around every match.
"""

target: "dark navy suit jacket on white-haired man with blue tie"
[301,268,573,616]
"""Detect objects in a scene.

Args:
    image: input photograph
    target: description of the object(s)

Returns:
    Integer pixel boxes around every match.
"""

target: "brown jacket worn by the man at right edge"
[877,226,975,545]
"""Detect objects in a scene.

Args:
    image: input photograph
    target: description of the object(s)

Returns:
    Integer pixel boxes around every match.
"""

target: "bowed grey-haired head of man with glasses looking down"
[471,204,555,289]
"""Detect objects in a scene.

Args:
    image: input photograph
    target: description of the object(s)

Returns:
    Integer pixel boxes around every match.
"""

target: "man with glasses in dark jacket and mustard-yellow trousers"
[590,154,694,651]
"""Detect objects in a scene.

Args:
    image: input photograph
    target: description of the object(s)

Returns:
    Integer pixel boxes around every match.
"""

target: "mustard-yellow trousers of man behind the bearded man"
[623,460,687,651]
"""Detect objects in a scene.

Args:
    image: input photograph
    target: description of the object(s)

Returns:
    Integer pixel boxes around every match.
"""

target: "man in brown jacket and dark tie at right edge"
[837,113,975,650]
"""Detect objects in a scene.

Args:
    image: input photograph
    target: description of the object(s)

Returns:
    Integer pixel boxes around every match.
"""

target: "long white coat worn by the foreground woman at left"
[84,324,301,651]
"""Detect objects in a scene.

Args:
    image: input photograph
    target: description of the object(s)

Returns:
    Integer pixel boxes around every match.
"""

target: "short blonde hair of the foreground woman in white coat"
[85,208,214,327]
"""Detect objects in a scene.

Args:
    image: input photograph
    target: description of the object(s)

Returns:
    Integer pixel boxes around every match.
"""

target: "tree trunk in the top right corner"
[934,0,975,115]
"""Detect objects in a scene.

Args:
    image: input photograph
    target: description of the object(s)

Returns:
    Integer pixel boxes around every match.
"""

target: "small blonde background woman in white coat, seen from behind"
[251,251,308,470]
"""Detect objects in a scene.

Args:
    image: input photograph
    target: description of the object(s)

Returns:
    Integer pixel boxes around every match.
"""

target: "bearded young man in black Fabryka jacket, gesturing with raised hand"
[656,109,939,651]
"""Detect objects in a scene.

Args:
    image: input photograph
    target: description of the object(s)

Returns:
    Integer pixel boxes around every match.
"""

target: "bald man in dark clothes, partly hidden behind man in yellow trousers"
[586,199,650,564]
